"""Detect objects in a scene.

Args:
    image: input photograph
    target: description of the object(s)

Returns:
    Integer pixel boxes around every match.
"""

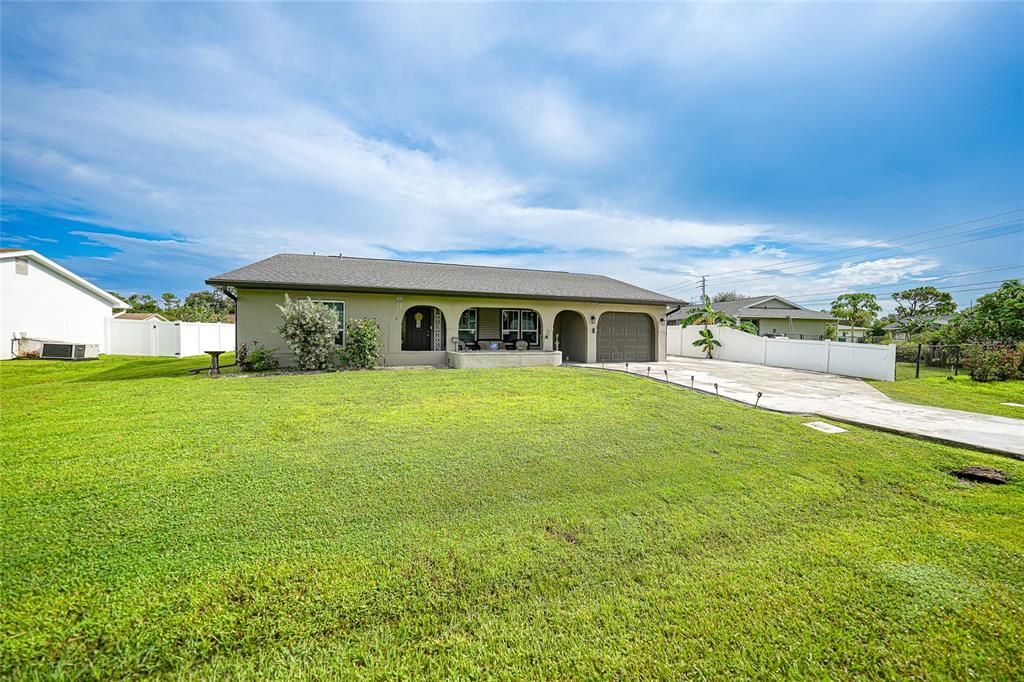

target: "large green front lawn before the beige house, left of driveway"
[6,358,1024,679]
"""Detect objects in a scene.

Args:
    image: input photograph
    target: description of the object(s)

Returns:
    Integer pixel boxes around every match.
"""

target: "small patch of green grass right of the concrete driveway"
[868,363,1024,419]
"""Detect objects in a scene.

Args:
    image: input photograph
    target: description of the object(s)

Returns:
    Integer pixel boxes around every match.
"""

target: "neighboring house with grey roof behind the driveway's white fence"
[669,296,839,339]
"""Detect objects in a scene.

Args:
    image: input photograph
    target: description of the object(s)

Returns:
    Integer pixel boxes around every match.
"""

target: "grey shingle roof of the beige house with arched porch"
[206,253,682,305]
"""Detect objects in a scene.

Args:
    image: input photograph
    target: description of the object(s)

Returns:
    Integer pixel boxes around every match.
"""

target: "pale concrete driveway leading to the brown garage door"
[585,355,1024,459]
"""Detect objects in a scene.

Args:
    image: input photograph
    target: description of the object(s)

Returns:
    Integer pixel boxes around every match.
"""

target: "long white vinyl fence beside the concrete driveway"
[667,326,896,381]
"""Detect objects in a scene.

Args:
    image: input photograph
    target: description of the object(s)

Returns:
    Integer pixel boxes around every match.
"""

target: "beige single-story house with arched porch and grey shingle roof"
[207,254,681,367]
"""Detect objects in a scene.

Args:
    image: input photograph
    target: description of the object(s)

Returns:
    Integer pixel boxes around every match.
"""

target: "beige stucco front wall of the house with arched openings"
[234,289,666,367]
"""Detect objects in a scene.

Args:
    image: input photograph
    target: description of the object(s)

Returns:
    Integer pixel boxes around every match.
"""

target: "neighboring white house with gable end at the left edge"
[0,249,129,359]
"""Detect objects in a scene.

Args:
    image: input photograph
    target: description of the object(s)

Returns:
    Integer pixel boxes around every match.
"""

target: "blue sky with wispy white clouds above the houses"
[0,2,1024,307]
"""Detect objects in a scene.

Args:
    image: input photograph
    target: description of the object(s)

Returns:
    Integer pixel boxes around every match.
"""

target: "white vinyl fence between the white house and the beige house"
[105,319,234,357]
